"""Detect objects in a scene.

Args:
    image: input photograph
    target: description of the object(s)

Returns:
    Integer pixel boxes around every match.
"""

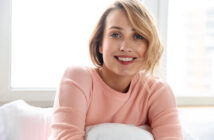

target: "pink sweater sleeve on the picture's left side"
[49,68,92,140]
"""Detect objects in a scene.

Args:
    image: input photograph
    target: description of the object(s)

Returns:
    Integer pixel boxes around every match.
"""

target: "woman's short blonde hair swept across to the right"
[89,0,163,74]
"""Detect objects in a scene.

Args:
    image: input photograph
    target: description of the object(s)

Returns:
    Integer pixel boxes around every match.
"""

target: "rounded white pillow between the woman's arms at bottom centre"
[86,123,154,140]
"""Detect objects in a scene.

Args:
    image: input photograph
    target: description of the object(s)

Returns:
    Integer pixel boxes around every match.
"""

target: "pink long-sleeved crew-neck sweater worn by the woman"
[51,67,183,140]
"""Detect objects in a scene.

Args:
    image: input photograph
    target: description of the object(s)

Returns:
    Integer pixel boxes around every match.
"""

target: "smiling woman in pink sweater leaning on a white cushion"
[51,0,183,140]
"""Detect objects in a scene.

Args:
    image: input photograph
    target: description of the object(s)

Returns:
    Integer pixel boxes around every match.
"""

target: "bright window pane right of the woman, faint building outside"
[167,0,214,96]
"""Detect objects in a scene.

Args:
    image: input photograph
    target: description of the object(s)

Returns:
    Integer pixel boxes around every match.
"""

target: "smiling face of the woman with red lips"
[99,9,147,76]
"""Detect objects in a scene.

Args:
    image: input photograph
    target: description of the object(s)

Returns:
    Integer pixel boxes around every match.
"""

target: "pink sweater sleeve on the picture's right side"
[148,82,183,140]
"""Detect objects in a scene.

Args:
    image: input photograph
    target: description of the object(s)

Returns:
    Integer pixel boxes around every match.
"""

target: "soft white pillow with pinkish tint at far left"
[0,100,53,140]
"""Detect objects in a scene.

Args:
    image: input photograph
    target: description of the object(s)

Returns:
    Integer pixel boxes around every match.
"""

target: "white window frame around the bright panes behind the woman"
[0,0,214,107]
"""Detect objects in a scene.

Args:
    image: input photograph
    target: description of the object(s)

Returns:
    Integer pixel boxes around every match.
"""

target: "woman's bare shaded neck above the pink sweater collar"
[98,68,133,93]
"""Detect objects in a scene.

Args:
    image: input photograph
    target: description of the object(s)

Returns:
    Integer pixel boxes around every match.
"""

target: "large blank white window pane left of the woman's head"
[11,0,113,89]
